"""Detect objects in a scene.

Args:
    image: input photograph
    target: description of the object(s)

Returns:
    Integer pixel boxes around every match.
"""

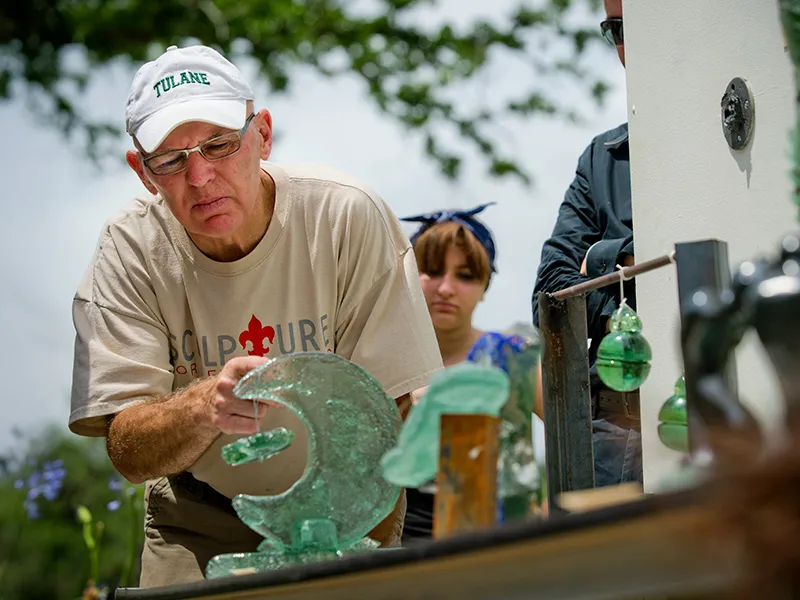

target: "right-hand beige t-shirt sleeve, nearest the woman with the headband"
[336,196,442,398]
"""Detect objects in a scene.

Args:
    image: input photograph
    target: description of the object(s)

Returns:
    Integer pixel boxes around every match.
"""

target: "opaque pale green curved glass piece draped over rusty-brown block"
[381,362,509,487]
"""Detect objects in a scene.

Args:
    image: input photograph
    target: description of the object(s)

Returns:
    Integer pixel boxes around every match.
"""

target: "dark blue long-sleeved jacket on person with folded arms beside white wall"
[532,123,636,370]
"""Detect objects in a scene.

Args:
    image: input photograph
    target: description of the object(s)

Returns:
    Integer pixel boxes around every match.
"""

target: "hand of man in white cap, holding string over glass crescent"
[210,356,268,435]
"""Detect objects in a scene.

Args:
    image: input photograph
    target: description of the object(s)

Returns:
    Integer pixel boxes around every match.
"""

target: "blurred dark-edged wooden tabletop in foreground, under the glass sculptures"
[116,498,746,600]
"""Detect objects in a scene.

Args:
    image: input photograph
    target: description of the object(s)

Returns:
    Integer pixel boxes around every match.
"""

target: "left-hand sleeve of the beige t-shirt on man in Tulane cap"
[69,233,173,437]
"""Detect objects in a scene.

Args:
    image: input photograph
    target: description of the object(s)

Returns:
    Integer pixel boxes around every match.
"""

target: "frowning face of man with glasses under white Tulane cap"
[127,110,272,246]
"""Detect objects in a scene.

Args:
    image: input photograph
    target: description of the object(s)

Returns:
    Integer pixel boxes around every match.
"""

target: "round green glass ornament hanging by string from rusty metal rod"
[595,303,653,392]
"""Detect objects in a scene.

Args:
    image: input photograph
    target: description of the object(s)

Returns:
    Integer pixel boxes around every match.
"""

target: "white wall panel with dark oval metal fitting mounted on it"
[624,0,797,490]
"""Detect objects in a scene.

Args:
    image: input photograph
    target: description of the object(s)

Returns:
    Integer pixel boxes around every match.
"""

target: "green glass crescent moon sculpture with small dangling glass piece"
[206,352,402,578]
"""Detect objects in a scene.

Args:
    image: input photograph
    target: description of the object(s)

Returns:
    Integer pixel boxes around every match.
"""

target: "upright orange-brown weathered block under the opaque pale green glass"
[433,415,500,539]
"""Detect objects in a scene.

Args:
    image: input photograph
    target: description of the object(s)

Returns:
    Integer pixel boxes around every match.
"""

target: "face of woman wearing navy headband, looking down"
[420,245,485,331]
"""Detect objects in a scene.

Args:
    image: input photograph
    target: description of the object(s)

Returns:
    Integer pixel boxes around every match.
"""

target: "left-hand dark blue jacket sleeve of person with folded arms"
[531,145,617,340]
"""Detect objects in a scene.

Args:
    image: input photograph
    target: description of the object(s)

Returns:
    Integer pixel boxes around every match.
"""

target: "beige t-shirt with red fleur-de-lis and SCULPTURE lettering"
[69,163,442,497]
